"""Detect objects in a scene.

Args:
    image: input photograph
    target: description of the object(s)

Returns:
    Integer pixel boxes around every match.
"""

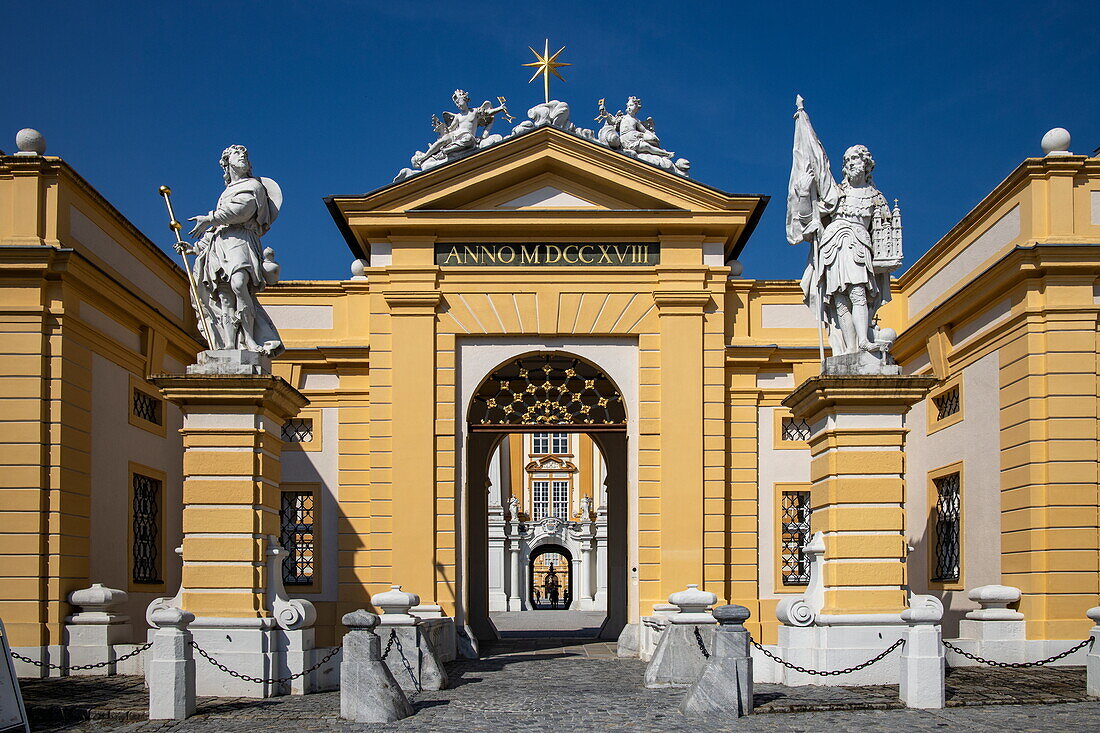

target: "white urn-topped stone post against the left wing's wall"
[65,583,133,675]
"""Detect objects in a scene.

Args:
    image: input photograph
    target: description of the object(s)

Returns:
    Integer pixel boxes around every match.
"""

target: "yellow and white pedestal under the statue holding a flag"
[779,375,937,685]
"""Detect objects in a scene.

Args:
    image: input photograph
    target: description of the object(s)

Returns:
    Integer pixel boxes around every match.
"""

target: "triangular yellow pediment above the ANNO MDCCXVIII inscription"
[326,127,767,256]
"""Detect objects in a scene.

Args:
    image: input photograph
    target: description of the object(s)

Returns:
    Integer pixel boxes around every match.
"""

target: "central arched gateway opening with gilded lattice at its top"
[465,351,629,641]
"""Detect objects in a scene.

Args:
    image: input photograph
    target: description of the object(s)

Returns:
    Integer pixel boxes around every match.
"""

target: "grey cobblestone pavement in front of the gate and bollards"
[22,638,1100,733]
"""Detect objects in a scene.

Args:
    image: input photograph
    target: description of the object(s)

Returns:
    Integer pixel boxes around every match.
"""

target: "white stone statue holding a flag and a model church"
[787,96,902,374]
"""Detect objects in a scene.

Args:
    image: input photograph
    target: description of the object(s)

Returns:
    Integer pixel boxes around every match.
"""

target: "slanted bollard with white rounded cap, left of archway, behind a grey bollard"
[371,586,448,692]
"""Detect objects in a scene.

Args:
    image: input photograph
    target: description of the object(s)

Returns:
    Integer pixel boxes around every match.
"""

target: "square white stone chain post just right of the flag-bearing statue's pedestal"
[899,605,944,709]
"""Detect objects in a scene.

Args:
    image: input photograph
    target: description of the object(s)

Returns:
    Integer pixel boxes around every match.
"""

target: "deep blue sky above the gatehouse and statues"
[0,0,1100,280]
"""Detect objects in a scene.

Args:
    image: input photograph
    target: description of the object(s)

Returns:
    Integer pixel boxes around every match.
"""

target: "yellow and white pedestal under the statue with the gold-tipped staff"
[146,374,316,697]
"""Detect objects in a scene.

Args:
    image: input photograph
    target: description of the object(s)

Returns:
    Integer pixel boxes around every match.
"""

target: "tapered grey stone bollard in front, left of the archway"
[340,609,413,723]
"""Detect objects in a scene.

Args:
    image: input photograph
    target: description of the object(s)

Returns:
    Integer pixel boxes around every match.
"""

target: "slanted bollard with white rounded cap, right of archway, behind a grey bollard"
[646,586,718,688]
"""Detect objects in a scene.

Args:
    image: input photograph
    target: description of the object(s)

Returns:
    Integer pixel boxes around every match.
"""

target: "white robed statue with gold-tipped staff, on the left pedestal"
[170,145,283,363]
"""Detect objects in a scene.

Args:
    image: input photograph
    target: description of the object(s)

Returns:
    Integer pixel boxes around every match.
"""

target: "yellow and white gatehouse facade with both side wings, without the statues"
[0,111,1100,674]
